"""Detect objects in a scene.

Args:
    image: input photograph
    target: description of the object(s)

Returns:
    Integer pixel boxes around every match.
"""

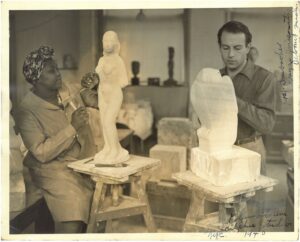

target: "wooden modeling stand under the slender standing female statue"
[68,155,160,233]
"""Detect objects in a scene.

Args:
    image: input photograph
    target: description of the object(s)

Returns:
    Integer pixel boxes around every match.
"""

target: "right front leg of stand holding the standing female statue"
[134,177,156,232]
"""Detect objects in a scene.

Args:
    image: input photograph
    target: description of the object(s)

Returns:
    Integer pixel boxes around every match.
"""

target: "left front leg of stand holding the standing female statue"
[87,181,106,233]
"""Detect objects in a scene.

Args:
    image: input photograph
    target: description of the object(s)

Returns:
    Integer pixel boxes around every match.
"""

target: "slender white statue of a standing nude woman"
[94,31,129,164]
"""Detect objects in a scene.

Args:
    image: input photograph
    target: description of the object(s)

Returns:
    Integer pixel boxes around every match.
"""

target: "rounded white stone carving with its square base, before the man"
[191,68,261,186]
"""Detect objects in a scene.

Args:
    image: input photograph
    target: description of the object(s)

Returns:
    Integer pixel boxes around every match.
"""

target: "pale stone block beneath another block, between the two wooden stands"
[149,145,187,179]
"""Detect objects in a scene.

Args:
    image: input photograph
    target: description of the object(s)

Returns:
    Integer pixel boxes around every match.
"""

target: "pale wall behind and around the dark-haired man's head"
[185,8,293,115]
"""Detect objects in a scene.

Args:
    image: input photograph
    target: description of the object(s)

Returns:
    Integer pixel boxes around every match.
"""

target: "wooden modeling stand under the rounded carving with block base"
[172,171,278,232]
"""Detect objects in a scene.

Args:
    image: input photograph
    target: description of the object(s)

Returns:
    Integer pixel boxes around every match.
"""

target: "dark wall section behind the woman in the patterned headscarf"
[10,11,99,107]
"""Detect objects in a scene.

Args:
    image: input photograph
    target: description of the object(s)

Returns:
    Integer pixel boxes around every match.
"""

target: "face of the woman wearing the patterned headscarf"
[37,60,62,90]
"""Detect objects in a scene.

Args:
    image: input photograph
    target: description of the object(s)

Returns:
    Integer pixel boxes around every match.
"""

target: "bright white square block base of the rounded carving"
[191,146,261,186]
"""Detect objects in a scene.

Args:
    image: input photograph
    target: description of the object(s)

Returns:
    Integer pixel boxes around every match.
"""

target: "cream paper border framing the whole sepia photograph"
[0,0,300,241]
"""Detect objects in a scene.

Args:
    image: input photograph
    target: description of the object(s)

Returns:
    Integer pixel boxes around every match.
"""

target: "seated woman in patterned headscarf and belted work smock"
[17,46,93,233]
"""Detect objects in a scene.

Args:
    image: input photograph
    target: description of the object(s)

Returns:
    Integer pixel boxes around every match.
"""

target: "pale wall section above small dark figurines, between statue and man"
[104,9,185,83]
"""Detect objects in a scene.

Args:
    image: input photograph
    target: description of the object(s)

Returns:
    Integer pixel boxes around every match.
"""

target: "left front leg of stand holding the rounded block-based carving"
[183,191,205,232]
